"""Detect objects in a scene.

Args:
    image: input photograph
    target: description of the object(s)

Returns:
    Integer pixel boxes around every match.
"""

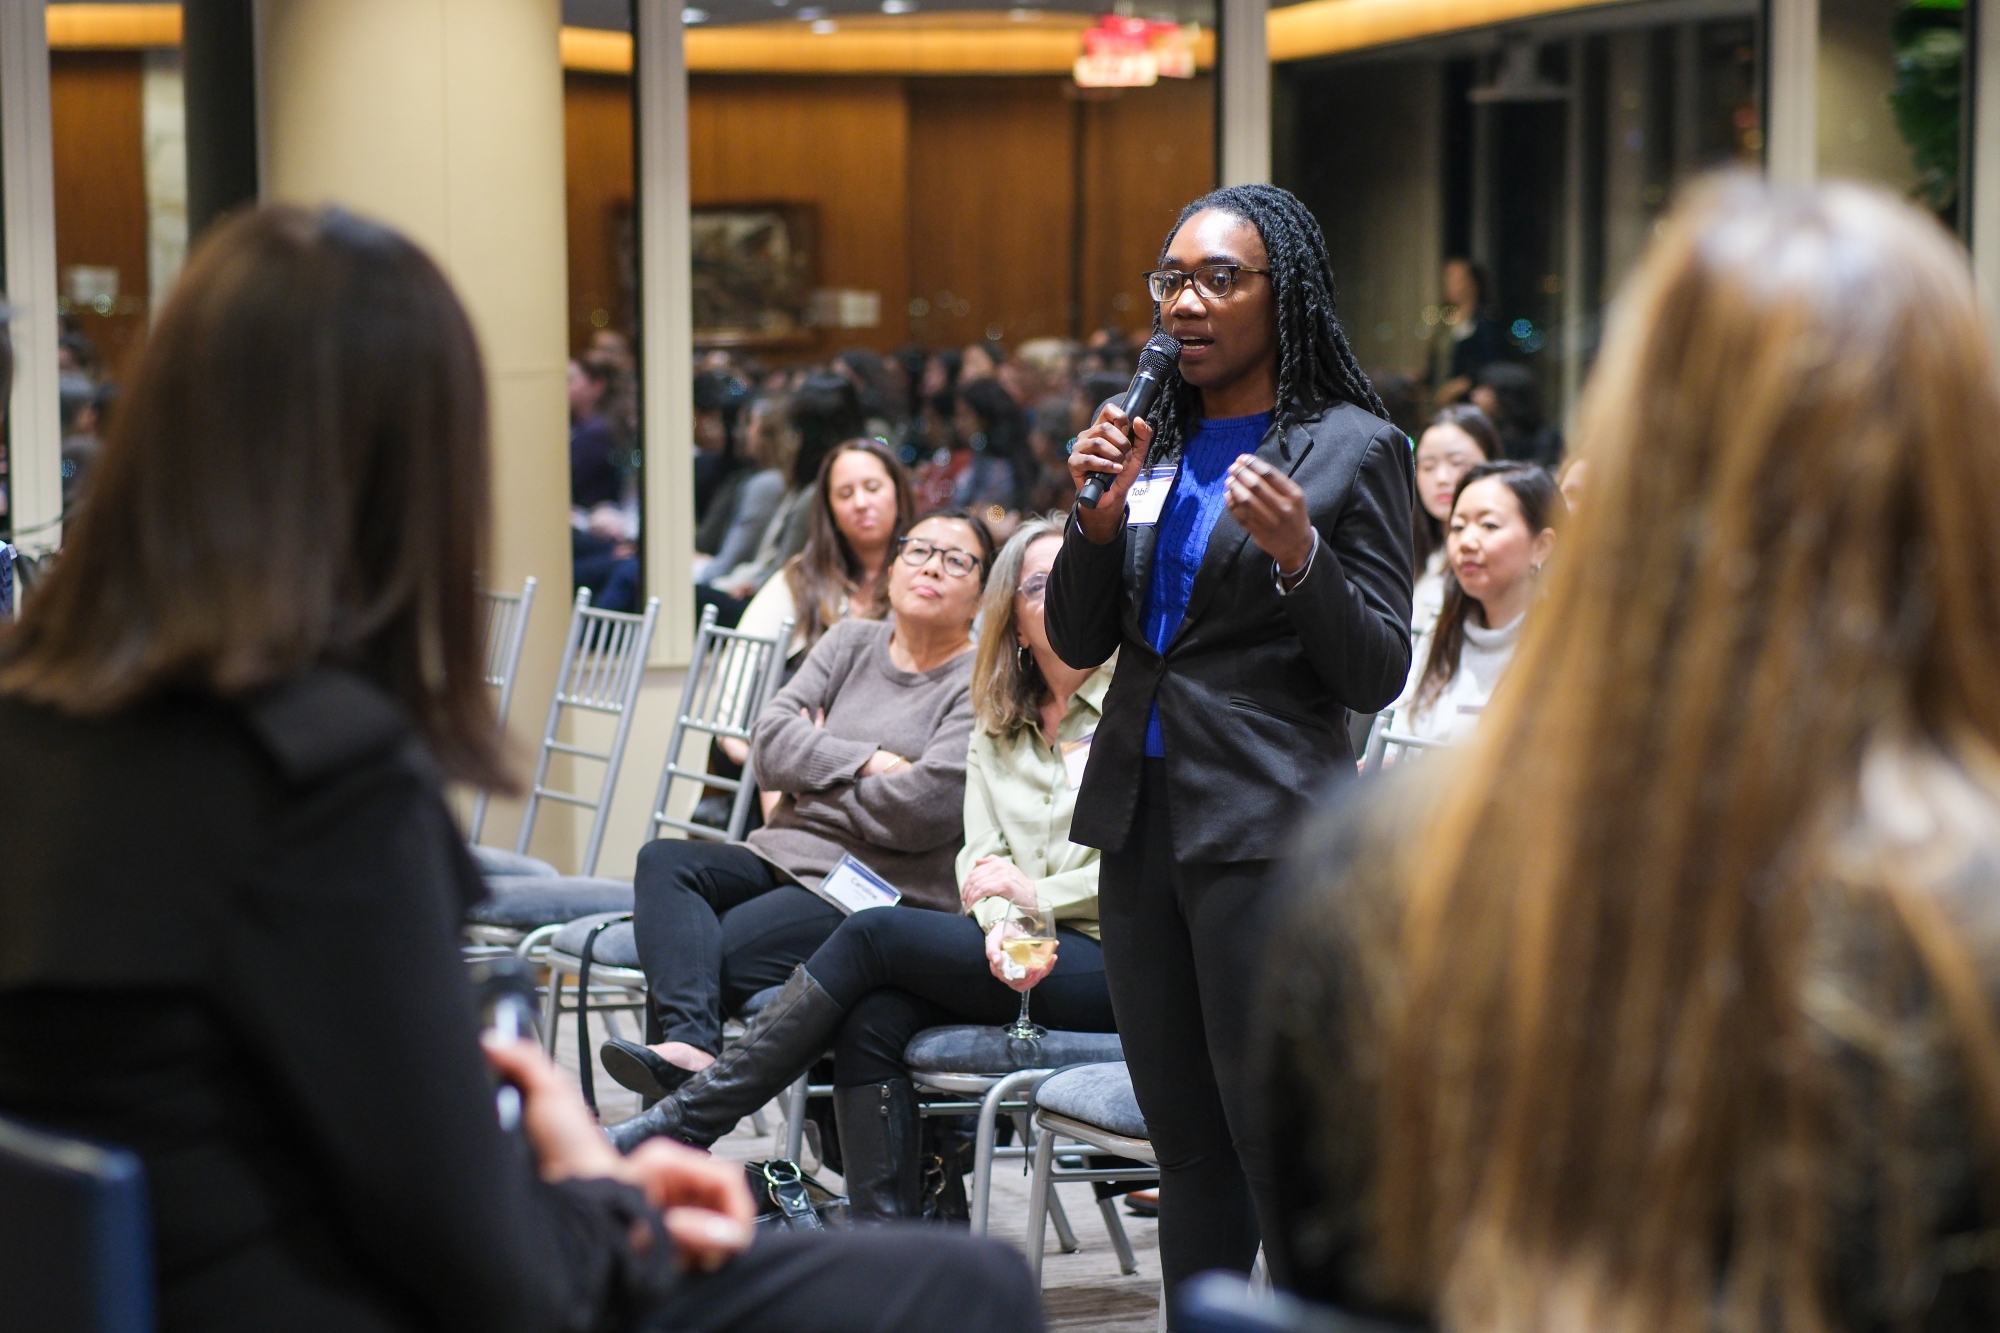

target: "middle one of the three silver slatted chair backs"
[514,588,660,877]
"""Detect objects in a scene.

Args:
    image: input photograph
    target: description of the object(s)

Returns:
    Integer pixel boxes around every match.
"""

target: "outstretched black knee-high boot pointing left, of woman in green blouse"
[608,967,846,1153]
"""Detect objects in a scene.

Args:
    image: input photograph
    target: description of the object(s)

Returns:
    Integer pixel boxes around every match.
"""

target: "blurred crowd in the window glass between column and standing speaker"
[570,328,1138,612]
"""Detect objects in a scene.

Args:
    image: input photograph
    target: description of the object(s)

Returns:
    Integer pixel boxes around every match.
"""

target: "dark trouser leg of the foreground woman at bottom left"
[644,1225,1042,1333]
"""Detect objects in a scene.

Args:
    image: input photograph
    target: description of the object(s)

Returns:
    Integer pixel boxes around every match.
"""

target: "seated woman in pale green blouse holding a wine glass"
[612,518,1114,1217]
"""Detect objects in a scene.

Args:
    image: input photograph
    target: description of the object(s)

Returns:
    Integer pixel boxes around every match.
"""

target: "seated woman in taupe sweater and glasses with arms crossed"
[616,512,992,1091]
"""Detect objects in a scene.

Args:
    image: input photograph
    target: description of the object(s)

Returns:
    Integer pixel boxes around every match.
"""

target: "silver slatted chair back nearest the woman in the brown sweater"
[646,606,792,843]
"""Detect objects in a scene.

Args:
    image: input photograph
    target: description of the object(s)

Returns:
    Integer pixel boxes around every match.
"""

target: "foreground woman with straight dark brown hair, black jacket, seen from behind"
[0,208,1038,1333]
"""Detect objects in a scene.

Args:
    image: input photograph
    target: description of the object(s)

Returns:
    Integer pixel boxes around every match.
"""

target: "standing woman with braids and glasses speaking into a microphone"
[1048,186,1414,1291]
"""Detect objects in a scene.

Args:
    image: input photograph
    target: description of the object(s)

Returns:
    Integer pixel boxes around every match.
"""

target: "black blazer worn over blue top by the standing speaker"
[1048,402,1416,861]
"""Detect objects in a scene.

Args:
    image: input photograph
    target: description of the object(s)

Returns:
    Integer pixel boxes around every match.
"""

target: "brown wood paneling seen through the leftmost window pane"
[48,50,150,370]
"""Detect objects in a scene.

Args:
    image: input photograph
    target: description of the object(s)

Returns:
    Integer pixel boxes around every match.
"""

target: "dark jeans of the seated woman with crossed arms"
[632,839,842,1055]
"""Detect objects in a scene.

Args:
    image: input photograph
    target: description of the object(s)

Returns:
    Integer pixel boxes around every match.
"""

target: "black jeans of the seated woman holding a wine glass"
[806,907,1116,1087]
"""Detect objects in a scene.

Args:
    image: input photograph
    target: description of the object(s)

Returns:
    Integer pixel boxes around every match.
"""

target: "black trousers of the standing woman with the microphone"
[1098,759,1278,1291]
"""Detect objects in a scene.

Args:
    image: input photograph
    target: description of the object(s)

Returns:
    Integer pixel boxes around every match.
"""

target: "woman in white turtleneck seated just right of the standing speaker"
[1394,462,1566,745]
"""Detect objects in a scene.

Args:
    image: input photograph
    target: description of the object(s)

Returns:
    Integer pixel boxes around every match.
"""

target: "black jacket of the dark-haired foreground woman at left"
[0,669,674,1333]
